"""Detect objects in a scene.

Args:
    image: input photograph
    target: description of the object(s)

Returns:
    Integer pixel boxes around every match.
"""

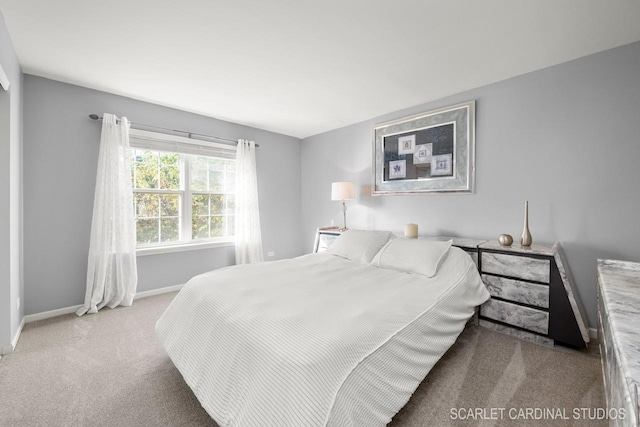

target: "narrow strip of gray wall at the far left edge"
[0,14,24,354]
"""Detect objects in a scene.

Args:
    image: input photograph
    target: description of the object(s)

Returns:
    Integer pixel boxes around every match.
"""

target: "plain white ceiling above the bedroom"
[0,0,640,138]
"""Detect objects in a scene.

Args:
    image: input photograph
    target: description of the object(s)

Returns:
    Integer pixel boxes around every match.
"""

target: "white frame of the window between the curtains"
[129,129,236,256]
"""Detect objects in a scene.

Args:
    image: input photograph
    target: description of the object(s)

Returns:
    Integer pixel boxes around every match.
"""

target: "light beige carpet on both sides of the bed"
[0,293,607,427]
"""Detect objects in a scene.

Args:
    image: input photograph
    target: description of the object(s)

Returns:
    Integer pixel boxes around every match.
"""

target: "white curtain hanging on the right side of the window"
[235,139,264,264]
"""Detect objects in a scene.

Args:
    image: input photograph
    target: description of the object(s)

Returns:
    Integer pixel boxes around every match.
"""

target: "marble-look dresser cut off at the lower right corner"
[598,260,640,427]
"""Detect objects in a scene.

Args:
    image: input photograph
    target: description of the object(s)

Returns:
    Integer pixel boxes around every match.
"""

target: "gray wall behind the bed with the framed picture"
[302,42,640,327]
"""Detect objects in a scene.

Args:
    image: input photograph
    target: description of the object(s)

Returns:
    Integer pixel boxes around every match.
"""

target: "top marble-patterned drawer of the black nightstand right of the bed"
[482,252,551,283]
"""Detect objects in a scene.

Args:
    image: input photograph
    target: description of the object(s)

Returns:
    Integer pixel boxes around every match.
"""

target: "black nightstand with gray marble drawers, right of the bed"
[478,241,589,347]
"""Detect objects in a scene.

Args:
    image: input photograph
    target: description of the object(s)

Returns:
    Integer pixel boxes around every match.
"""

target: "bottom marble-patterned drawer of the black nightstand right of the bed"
[480,299,549,335]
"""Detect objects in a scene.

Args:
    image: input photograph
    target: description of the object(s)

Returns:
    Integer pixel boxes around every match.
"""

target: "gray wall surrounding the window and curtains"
[24,75,301,314]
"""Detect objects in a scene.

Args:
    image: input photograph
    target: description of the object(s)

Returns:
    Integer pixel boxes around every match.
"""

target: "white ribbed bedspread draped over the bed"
[156,248,489,427]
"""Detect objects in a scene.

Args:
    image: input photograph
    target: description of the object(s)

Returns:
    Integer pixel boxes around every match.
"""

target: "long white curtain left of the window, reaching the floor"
[76,113,138,316]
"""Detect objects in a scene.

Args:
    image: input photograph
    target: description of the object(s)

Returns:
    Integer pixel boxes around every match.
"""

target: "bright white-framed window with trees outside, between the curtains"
[130,129,236,247]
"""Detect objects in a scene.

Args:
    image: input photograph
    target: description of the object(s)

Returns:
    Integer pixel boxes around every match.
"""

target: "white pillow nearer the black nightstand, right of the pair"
[371,239,452,277]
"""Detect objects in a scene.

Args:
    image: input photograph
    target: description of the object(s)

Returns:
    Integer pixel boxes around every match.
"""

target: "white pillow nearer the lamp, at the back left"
[327,230,392,264]
